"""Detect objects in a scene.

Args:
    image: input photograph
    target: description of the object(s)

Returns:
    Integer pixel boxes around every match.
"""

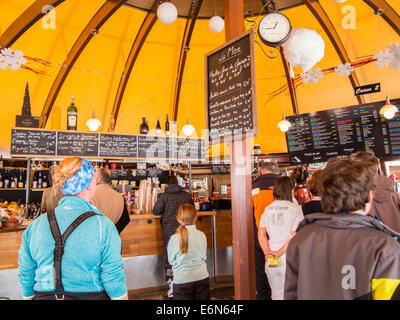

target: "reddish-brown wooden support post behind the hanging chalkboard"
[224,0,256,300]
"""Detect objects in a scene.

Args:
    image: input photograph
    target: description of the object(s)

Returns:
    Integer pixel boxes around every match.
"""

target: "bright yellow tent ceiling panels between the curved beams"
[0,0,400,157]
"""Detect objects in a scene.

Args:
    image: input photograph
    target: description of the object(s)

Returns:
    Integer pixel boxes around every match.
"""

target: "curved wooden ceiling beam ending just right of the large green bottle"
[108,0,162,132]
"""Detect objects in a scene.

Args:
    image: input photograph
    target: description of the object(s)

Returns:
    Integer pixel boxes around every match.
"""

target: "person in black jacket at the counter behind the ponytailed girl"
[153,176,193,298]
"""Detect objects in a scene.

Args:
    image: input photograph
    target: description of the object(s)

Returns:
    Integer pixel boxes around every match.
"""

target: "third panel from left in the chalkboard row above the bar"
[99,133,138,158]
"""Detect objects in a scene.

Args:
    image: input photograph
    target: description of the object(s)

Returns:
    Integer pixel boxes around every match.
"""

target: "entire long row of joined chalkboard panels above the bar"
[11,128,205,161]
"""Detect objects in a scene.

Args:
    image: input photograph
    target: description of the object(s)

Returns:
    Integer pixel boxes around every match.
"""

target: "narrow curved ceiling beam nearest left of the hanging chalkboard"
[172,0,203,121]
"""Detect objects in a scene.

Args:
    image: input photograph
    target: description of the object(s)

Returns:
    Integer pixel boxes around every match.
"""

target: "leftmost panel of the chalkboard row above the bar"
[11,129,57,155]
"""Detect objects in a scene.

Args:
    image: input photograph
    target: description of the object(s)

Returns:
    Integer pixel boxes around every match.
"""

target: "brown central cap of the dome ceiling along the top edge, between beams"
[126,0,303,19]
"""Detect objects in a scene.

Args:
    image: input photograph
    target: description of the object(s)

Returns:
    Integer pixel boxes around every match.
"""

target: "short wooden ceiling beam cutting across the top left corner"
[0,0,65,48]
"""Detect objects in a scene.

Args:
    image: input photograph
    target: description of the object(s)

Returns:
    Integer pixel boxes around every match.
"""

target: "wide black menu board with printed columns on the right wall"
[286,99,400,165]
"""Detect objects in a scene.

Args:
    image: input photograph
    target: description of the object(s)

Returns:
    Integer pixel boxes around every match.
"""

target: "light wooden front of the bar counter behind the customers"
[0,210,232,270]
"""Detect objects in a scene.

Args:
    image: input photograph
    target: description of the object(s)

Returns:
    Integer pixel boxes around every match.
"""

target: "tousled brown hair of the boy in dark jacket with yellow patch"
[321,159,375,213]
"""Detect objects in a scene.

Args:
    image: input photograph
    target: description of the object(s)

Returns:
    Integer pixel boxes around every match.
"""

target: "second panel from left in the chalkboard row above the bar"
[57,132,99,157]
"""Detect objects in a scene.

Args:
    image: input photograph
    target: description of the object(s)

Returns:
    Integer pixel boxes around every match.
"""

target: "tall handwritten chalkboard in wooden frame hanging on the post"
[205,29,257,143]
